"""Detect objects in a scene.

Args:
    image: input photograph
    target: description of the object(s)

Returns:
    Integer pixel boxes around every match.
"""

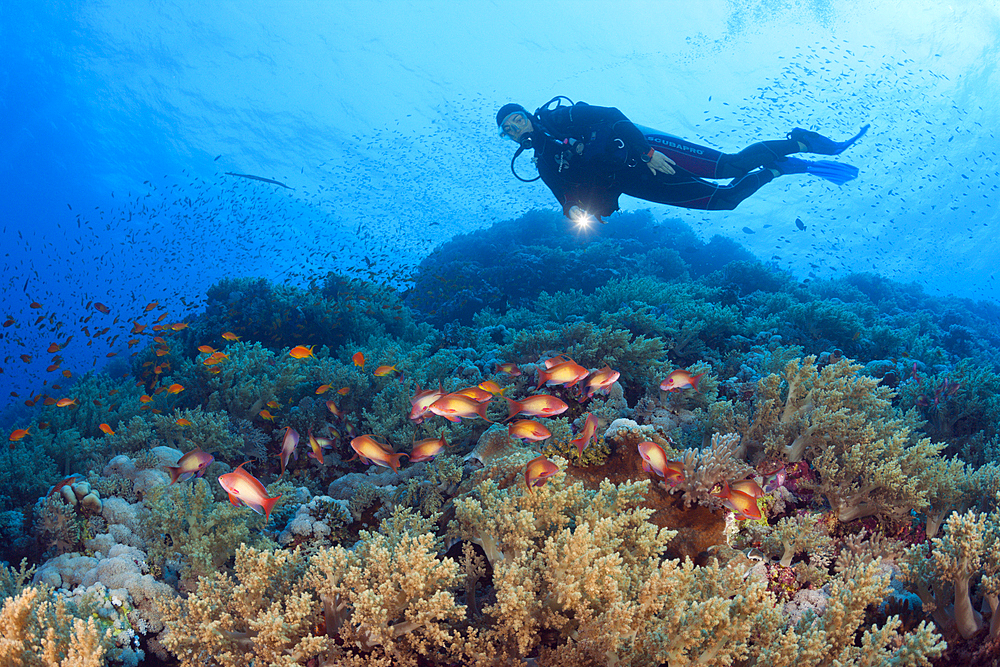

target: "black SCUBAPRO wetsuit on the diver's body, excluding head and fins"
[530,102,801,216]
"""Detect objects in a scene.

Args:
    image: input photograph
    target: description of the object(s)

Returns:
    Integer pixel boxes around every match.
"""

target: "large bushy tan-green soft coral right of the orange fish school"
[745,356,955,521]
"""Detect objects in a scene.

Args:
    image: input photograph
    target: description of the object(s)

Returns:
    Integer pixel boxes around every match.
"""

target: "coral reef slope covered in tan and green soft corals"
[0,212,1000,667]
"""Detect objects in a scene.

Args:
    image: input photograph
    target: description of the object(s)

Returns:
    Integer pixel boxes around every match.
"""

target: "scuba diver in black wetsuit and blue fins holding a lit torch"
[497,95,869,224]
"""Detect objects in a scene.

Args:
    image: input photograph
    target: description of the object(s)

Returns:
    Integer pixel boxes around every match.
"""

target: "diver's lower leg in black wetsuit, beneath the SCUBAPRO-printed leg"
[621,169,775,211]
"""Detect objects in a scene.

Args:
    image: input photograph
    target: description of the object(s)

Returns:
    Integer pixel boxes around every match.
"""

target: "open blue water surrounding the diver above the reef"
[0,0,1000,414]
